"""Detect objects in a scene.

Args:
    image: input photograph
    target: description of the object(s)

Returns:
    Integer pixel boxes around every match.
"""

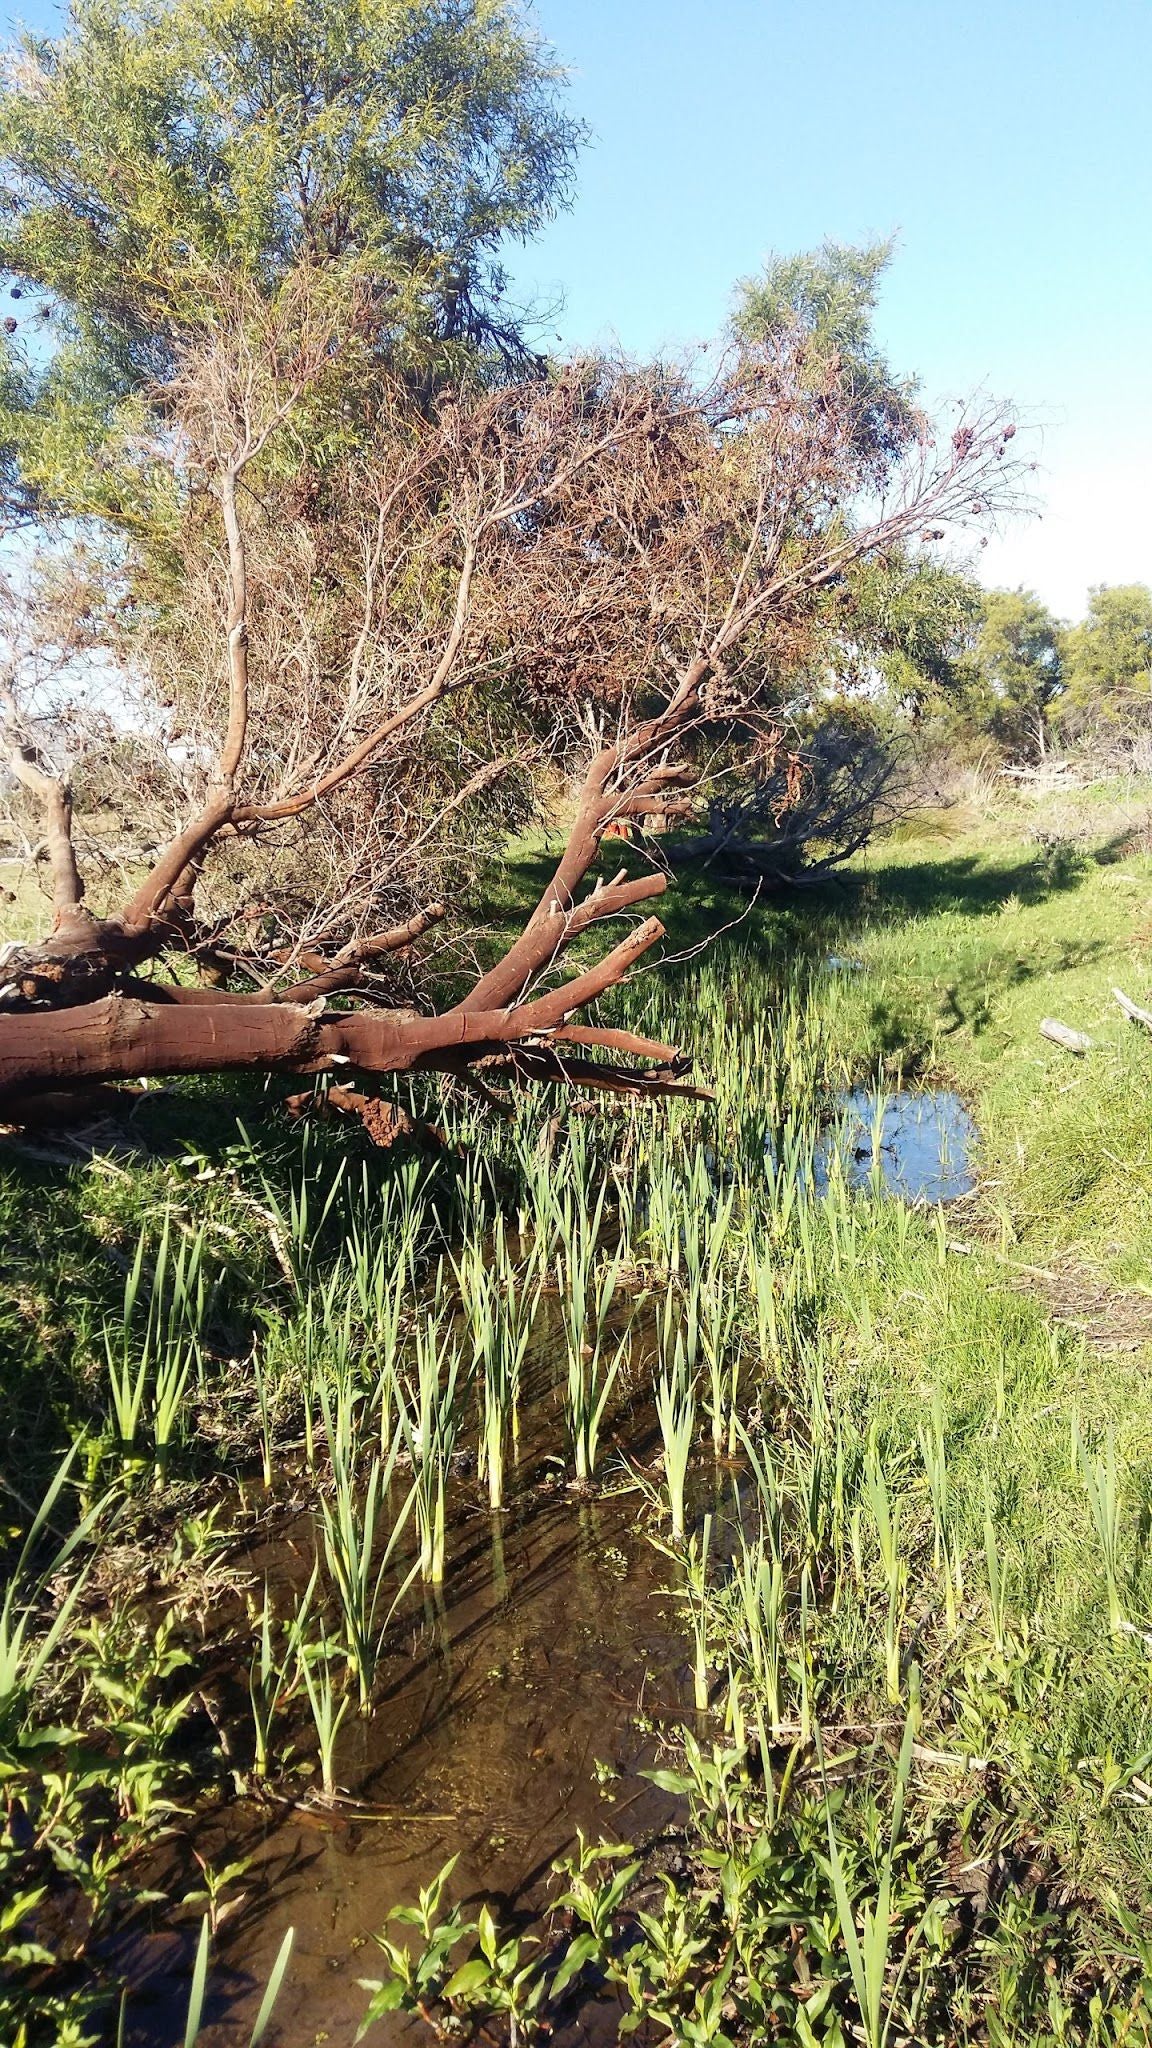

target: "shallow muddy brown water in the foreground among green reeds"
[119,1335,709,2048]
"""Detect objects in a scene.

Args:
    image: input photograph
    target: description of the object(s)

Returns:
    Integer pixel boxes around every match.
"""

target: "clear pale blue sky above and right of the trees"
[512,0,1152,616]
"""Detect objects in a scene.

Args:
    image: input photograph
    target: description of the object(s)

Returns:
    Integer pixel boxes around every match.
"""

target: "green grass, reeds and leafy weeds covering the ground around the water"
[0,793,1152,2048]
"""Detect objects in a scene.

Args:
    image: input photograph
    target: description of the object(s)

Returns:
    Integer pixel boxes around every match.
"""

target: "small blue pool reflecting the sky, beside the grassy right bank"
[814,1087,978,1202]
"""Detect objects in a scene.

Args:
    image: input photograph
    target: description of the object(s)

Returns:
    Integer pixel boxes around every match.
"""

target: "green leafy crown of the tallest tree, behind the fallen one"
[0,0,578,528]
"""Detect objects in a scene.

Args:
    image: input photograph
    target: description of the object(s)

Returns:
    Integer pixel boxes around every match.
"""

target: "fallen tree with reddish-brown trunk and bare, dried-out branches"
[0,331,1013,1116]
